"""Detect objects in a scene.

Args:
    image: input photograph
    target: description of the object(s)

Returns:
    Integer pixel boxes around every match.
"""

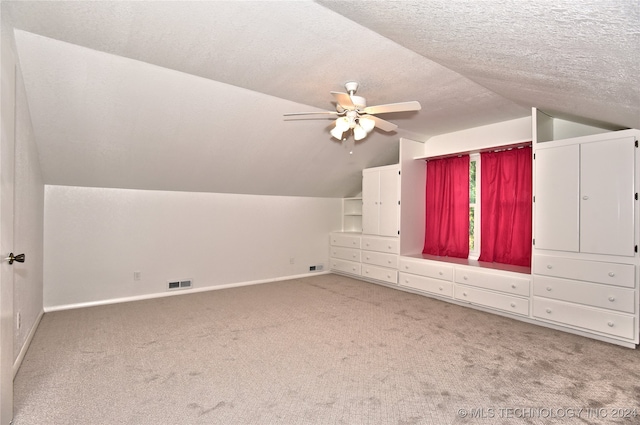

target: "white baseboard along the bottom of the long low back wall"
[44,271,331,313]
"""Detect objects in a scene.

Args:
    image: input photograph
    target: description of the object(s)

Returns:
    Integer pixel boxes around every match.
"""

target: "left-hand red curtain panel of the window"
[422,155,469,258]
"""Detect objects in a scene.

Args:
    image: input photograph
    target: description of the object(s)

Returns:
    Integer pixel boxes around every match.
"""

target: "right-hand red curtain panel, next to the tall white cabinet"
[478,147,532,267]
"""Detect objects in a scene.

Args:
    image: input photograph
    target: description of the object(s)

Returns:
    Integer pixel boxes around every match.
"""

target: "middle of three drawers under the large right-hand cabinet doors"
[533,276,636,313]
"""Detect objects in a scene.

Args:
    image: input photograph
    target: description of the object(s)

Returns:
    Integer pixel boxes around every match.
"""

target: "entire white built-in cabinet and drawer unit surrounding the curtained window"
[330,121,640,348]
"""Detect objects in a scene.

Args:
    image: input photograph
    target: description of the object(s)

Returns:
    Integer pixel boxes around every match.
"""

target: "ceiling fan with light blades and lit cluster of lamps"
[284,81,422,140]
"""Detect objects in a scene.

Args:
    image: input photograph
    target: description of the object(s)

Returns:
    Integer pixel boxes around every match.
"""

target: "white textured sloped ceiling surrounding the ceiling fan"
[2,0,640,197]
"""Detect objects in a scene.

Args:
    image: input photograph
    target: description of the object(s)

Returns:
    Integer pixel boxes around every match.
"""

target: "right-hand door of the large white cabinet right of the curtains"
[580,137,635,257]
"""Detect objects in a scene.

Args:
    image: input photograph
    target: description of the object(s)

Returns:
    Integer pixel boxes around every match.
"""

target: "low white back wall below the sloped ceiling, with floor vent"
[44,186,341,311]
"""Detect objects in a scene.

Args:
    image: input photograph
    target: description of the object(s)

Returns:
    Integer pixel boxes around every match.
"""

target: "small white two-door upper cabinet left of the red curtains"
[362,165,400,236]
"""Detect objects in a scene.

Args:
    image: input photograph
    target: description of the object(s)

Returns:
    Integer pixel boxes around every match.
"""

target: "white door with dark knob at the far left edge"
[0,57,15,425]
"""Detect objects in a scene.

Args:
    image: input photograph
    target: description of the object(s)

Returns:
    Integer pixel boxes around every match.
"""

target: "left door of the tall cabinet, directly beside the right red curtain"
[534,145,580,252]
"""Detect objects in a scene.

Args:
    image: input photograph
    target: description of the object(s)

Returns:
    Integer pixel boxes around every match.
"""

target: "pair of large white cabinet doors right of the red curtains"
[534,134,637,257]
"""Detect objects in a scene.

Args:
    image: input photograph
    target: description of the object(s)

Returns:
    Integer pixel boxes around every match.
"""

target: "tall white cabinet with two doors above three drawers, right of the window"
[532,130,640,345]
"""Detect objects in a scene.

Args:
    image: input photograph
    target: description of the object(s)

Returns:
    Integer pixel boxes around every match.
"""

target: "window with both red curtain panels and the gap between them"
[423,146,532,267]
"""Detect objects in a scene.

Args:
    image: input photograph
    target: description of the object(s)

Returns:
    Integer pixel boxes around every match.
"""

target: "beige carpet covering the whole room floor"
[14,274,640,425]
